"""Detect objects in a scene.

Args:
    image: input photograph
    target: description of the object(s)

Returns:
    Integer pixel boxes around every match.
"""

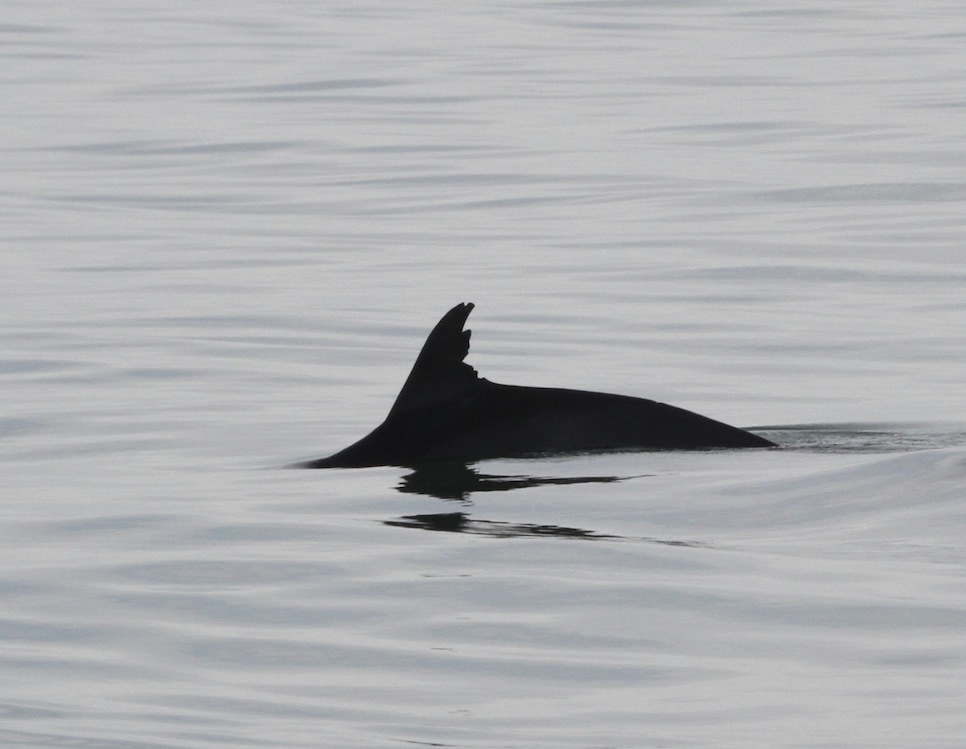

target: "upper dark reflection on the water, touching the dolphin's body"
[396,463,638,501]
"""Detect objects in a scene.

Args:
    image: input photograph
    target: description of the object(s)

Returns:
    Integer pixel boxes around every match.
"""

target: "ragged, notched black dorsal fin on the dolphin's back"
[387,302,479,418]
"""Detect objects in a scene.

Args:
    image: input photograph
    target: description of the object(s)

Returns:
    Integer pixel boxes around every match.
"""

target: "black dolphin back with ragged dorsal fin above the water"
[299,304,775,468]
